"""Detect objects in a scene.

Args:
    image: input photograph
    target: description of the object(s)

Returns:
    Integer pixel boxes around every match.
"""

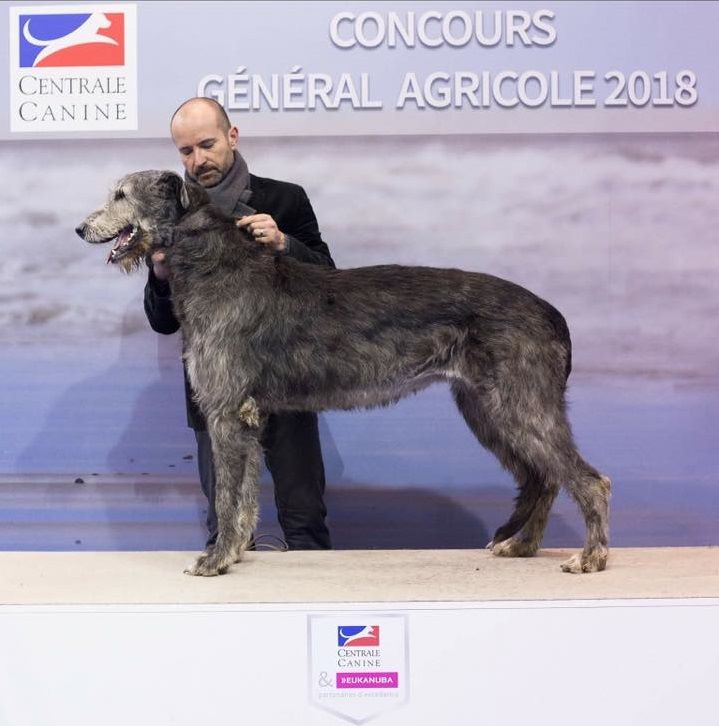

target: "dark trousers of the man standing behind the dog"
[195,413,332,550]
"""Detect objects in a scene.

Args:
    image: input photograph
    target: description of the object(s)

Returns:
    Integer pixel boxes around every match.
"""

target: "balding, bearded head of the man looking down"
[170,98,238,187]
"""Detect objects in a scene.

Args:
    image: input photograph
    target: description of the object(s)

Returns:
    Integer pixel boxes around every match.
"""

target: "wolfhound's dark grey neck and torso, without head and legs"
[160,207,570,418]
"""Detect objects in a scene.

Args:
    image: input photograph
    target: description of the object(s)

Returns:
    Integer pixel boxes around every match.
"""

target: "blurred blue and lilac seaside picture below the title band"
[0,134,719,549]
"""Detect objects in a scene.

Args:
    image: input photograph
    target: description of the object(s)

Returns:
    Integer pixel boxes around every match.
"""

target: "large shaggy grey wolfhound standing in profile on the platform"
[77,171,610,575]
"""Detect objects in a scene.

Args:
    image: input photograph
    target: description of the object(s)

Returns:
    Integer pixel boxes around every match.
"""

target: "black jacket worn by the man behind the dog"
[145,174,335,431]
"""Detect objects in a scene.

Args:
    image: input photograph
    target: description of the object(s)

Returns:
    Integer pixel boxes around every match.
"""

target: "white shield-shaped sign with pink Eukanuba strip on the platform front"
[308,612,409,724]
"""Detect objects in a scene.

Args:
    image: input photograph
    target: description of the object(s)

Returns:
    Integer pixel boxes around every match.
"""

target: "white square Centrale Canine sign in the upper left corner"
[9,3,137,132]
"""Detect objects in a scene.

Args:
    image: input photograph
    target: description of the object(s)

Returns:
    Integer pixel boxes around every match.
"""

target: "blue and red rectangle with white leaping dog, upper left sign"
[18,12,125,68]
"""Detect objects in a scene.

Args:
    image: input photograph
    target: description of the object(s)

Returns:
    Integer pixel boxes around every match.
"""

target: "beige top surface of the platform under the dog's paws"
[0,547,719,605]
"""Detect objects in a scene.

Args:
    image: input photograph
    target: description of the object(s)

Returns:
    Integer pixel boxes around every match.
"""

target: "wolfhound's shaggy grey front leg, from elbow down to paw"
[185,411,262,577]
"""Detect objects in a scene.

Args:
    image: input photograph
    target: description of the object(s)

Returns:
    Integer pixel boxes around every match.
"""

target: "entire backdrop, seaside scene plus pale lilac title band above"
[0,2,719,549]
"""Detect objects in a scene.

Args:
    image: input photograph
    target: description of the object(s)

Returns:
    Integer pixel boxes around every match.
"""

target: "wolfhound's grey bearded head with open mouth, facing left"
[75,171,209,272]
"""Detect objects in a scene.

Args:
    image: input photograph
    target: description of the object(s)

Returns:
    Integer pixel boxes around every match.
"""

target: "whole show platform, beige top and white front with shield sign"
[0,547,719,726]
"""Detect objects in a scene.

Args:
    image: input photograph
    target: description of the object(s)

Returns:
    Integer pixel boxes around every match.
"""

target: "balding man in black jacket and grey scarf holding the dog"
[145,98,334,549]
